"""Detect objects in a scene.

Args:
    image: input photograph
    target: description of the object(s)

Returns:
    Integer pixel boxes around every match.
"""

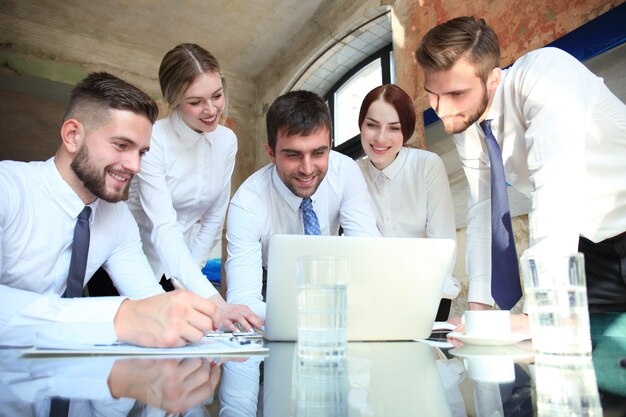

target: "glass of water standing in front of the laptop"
[296,256,348,360]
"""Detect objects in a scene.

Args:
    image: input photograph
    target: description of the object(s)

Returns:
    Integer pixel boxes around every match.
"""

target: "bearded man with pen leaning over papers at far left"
[0,73,219,347]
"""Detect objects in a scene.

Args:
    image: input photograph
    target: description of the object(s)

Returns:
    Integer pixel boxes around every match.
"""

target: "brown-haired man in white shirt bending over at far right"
[416,17,626,328]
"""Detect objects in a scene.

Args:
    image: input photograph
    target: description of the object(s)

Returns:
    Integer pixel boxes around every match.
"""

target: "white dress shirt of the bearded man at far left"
[0,158,163,346]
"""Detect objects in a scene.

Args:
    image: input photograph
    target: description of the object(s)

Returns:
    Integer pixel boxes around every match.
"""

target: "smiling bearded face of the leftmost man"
[70,110,152,203]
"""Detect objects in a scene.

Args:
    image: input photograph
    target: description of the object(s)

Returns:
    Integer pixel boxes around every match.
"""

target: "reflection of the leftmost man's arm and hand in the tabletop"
[0,350,232,416]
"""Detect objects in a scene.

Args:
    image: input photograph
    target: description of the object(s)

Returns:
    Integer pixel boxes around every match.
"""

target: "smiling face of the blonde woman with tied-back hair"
[178,72,226,132]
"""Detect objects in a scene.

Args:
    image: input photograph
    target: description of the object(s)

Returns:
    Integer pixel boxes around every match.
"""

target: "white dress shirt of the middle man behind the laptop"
[226,151,380,318]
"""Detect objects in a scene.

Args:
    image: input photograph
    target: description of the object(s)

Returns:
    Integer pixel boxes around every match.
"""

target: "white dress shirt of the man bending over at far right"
[454,48,626,304]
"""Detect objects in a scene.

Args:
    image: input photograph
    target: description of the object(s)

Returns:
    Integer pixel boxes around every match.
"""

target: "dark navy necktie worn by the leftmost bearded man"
[63,206,91,298]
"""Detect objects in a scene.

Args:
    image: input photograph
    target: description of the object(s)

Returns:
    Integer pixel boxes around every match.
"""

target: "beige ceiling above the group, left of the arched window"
[0,0,380,95]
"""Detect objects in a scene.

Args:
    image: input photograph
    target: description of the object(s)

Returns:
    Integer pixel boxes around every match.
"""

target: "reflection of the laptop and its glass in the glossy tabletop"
[263,342,452,417]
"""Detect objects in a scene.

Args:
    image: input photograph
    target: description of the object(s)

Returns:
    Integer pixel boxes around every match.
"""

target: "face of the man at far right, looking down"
[424,59,494,133]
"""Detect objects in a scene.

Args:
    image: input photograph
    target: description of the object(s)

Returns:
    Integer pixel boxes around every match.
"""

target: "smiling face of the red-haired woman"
[361,98,404,170]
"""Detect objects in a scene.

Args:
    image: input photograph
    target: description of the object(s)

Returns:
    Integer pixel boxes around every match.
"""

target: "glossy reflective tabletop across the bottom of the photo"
[0,338,626,417]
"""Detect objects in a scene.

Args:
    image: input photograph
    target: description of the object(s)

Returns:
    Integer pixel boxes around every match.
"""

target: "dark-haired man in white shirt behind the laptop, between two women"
[226,91,380,319]
